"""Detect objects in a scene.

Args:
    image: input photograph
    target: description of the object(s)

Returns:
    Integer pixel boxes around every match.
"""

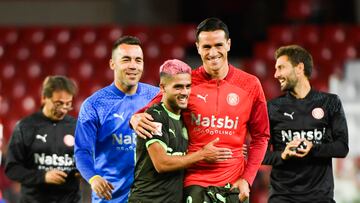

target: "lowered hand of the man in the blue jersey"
[91,176,114,200]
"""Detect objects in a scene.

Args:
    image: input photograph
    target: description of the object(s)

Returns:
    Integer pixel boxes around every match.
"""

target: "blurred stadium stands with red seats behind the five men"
[0,0,360,203]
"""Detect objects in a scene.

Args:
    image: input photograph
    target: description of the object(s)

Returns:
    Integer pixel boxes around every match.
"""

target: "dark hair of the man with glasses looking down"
[41,75,78,98]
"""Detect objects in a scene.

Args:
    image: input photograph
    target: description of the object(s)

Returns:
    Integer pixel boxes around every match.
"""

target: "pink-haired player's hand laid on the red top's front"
[202,138,232,162]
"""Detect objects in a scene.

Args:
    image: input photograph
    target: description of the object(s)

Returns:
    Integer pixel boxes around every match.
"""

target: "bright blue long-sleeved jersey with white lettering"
[75,83,159,202]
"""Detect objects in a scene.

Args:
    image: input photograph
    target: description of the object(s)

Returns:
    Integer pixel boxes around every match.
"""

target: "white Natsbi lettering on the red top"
[191,113,239,129]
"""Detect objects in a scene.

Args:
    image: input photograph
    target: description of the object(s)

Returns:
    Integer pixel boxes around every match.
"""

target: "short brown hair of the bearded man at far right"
[275,45,314,79]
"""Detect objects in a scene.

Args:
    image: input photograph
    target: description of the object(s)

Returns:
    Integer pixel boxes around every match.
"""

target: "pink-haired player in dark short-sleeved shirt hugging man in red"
[129,59,231,203]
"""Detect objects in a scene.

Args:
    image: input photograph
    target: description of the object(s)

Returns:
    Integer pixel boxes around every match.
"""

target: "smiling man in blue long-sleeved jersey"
[75,36,159,203]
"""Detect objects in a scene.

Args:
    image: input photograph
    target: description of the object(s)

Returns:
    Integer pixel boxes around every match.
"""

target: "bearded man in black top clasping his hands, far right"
[263,45,349,203]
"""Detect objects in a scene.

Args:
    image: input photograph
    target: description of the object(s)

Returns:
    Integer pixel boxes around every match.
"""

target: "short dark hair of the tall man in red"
[196,17,230,42]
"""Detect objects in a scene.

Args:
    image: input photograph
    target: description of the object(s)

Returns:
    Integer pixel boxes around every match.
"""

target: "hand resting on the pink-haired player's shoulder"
[130,113,156,139]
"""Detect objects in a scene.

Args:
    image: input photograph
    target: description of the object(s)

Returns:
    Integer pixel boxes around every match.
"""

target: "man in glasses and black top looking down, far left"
[5,76,80,203]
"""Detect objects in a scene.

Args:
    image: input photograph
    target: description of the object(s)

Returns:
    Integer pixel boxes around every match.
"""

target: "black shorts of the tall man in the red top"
[184,184,245,203]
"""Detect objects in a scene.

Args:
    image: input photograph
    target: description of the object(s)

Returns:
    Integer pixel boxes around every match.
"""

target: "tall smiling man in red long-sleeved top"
[131,18,270,203]
